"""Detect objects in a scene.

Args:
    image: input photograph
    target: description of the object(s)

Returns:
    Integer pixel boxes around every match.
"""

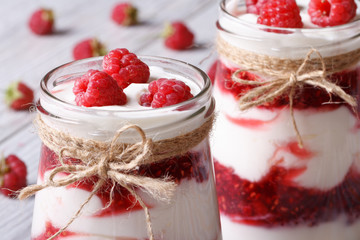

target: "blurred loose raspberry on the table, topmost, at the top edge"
[111,2,138,26]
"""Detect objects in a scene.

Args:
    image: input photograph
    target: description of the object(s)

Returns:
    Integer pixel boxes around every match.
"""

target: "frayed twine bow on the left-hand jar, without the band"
[18,118,175,240]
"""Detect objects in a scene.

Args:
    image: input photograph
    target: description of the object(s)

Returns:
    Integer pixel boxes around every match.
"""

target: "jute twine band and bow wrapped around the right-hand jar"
[217,36,360,148]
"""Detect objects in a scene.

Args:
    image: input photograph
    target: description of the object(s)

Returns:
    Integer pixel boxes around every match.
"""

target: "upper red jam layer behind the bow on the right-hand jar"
[215,61,360,112]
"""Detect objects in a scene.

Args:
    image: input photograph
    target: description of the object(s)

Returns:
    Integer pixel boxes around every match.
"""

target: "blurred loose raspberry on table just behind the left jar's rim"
[73,38,107,60]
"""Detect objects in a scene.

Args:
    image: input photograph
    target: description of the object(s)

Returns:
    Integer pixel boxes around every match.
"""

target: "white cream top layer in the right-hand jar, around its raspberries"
[218,0,360,59]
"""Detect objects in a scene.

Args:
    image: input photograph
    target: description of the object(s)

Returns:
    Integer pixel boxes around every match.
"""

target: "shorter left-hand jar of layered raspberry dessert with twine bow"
[20,49,222,240]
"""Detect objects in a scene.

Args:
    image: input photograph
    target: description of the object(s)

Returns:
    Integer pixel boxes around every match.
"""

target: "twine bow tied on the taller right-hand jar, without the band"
[232,49,357,148]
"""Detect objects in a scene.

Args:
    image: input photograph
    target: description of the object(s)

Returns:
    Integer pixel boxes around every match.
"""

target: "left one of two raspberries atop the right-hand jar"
[257,0,303,28]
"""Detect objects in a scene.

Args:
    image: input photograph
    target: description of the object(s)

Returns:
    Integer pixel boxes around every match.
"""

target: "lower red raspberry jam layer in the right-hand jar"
[215,161,360,227]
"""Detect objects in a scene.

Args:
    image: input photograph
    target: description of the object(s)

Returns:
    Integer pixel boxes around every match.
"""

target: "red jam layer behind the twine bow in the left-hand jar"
[39,145,211,217]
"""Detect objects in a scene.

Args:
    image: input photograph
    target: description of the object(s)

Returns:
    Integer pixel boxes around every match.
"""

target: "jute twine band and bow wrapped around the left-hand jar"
[18,115,214,240]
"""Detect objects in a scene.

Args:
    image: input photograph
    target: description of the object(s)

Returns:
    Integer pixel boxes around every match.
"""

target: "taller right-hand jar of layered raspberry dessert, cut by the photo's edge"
[212,0,360,240]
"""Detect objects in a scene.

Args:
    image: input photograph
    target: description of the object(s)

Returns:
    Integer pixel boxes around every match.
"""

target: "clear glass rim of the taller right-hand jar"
[217,0,360,36]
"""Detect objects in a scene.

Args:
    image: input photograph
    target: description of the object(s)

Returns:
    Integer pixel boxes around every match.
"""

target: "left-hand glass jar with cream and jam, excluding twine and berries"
[32,56,221,240]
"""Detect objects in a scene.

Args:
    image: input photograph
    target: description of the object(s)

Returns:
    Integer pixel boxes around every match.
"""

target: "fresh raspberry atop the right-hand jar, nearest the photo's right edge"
[308,0,357,27]
